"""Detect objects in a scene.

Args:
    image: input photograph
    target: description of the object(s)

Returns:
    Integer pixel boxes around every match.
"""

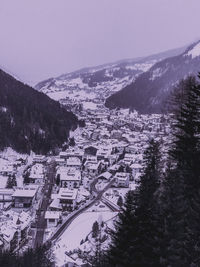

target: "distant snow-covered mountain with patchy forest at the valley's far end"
[35,48,183,101]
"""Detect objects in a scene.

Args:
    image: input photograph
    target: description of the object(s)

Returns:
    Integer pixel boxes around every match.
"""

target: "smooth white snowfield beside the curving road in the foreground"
[54,211,117,266]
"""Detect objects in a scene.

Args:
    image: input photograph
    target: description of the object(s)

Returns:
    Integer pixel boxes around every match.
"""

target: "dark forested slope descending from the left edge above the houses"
[0,70,78,153]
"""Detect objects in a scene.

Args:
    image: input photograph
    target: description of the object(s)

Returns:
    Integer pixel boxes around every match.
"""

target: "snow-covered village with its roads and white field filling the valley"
[0,99,170,266]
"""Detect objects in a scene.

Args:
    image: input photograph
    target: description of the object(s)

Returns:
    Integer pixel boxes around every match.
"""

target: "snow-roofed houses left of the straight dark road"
[0,158,44,251]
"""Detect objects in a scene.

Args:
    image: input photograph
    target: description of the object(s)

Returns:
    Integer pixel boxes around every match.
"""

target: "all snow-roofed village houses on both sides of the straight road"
[0,101,170,260]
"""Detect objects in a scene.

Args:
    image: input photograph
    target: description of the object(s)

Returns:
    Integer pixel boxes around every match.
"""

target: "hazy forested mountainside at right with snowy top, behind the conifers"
[106,41,200,113]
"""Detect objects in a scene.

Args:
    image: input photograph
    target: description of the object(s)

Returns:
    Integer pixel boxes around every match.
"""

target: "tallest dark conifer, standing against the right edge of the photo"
[162,74,200,266]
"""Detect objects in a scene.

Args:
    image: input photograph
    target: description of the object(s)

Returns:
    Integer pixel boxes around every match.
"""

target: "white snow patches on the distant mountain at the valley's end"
[40,61,155,103]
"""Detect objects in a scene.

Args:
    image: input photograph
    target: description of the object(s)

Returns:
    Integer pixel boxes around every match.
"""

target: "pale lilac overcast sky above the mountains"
[0,0,200,84]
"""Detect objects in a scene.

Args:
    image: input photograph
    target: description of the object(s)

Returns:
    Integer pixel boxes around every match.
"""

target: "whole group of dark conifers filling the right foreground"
[95,75,200,267]
